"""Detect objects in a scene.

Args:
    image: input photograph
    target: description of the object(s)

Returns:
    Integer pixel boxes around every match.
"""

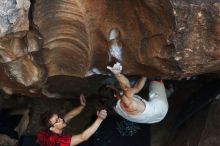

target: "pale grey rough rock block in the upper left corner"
[0,0,30,38]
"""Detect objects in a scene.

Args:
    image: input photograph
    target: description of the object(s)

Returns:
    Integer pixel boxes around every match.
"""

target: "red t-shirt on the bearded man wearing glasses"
[37,131,71,146]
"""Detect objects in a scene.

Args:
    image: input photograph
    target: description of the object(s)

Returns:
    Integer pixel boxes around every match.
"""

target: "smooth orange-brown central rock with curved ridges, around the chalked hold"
[31,0,174,77]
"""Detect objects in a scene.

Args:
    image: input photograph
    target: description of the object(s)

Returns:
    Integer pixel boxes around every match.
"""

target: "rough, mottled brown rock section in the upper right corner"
[172,0,220,75]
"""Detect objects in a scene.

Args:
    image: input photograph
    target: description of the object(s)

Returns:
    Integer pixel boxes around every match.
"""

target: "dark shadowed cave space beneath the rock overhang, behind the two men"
[0,75,220,146]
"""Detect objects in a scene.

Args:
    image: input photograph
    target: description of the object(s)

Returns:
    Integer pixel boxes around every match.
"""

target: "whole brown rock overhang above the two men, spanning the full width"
[0,0,220,97]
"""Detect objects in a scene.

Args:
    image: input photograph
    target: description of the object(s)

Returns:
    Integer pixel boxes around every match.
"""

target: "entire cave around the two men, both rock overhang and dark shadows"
[0,0,220,146]
